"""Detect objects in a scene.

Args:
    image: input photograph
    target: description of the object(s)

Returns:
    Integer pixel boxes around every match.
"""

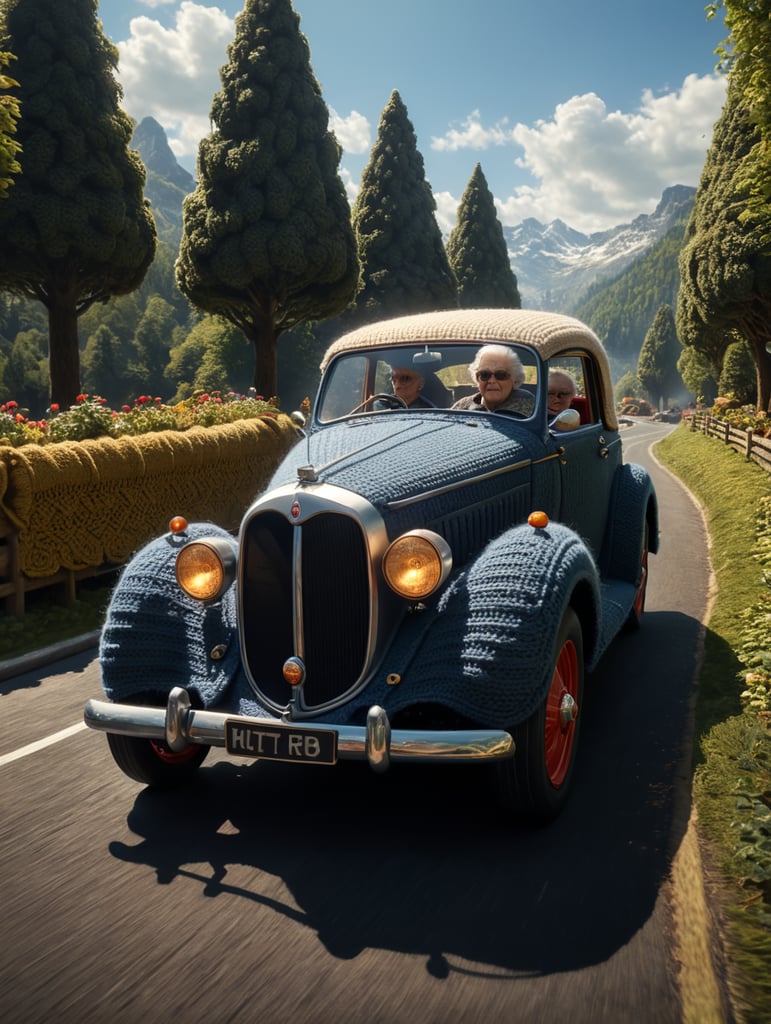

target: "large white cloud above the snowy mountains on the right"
[432,75,726,231]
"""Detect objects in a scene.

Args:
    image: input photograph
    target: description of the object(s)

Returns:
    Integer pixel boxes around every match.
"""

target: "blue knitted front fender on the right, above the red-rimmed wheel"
[348,523,601,728]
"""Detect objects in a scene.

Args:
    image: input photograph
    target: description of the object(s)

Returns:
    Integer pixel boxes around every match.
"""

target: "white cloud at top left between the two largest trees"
[118,0,235,164]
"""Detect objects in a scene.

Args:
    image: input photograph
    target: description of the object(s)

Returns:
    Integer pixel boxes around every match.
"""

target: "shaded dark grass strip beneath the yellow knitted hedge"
[0,574,115,660]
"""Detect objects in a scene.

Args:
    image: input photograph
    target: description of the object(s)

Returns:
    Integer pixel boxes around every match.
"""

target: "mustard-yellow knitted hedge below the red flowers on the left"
[0,416,299,578]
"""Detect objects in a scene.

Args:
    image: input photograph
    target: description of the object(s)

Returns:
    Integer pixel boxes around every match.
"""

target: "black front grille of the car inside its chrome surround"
[242,510,370,708]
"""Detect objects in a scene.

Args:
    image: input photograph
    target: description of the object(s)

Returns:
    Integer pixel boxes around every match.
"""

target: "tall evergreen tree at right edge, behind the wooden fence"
[677,81,771,410]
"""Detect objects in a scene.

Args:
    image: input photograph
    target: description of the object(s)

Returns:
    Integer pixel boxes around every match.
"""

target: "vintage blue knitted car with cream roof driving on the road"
[85,309,658,820]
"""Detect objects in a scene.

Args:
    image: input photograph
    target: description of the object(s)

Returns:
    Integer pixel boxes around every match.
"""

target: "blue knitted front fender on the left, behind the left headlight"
[99,523,241,708]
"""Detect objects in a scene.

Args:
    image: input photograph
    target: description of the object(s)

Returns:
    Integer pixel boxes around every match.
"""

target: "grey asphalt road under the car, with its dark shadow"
[0,423,710,1024]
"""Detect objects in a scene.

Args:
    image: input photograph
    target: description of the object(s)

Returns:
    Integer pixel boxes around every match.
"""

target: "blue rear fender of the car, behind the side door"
[600,463,658,584]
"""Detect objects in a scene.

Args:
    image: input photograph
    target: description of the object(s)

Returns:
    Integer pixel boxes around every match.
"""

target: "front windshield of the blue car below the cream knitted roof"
[315,343,539,423]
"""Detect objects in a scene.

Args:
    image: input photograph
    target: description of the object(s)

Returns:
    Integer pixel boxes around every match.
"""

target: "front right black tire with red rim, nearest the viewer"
[495,608,584,823]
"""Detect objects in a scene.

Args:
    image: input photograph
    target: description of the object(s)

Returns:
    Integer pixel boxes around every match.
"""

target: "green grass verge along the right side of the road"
[655,425,771,1024]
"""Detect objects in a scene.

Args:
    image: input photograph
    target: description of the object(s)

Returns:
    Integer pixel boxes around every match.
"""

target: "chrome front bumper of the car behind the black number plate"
[83,686,514,772]
